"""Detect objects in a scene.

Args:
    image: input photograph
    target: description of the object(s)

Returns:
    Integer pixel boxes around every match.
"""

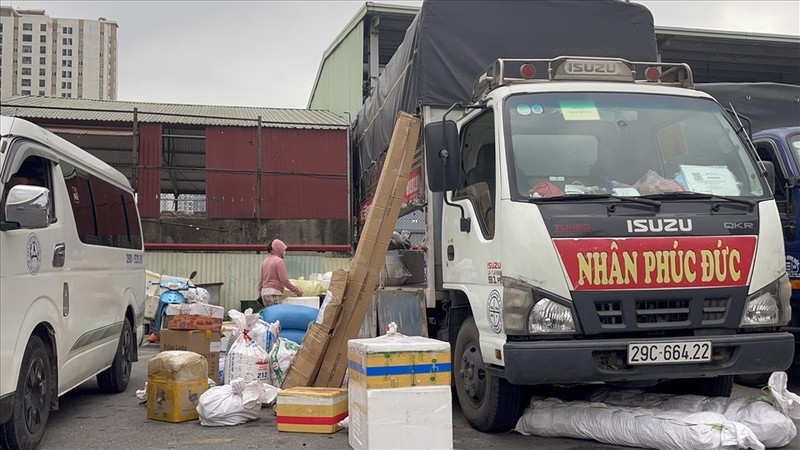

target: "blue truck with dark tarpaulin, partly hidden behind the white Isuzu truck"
[696,83,800,386]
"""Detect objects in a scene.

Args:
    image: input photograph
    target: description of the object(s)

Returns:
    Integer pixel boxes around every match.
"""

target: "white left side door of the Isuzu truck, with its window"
[442,109,503,363]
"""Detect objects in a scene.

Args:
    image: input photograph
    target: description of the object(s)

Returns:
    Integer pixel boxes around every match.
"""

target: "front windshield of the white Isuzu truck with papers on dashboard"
[504,93,765,201]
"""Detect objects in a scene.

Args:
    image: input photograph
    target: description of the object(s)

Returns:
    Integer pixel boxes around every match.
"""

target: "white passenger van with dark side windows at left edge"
[0,116,145,448]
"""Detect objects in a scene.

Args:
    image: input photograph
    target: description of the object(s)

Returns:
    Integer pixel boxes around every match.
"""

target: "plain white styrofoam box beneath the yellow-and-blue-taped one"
[347,383,453,450]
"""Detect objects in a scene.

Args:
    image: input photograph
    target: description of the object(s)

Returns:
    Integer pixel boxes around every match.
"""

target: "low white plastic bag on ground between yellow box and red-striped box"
[197,378,278,427]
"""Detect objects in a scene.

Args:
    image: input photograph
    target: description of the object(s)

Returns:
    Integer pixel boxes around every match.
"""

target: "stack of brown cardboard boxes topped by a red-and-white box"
[160,303,225,384]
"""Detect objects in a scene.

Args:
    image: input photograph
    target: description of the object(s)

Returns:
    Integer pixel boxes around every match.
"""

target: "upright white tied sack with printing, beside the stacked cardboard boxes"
[224,308,270,384]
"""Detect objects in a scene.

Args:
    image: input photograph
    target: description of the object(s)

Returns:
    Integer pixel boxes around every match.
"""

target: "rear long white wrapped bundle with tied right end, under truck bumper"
[592,378,797,448]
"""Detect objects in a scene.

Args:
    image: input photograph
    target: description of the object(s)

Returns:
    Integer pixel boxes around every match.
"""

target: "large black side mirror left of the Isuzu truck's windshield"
[425,120,461,192]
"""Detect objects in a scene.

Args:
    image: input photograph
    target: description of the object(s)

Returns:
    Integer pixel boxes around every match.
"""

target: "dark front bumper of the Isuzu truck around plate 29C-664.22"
[503,332,794,384]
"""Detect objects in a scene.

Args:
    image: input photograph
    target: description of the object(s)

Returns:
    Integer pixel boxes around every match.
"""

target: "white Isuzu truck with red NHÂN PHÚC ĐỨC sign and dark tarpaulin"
[354,1,794,431]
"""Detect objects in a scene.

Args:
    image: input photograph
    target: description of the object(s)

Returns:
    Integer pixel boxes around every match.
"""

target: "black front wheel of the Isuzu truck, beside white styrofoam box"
[453,317,522,432]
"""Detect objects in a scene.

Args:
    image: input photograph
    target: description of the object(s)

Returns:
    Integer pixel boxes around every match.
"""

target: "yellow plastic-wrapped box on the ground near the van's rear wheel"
[147,351,208,422]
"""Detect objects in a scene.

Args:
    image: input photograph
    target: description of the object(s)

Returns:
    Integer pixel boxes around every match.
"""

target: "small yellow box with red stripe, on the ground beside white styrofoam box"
[275,387,347,433]
